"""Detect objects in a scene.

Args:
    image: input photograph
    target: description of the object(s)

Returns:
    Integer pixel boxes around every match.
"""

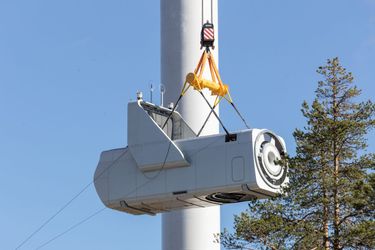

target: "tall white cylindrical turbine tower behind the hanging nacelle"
[160,0,220,250]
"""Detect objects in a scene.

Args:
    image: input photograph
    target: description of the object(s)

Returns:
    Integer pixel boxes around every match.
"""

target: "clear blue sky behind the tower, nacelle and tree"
[0,0,375,250]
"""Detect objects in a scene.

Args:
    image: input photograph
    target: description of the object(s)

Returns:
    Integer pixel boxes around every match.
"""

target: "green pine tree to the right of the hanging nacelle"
[221,58,375,250]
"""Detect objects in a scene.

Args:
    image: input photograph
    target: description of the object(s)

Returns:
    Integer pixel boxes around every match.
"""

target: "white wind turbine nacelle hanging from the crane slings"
[94,100,288,214]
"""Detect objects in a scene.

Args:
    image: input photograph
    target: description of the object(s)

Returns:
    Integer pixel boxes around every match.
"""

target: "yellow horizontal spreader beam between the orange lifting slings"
[186,72,228,96]
